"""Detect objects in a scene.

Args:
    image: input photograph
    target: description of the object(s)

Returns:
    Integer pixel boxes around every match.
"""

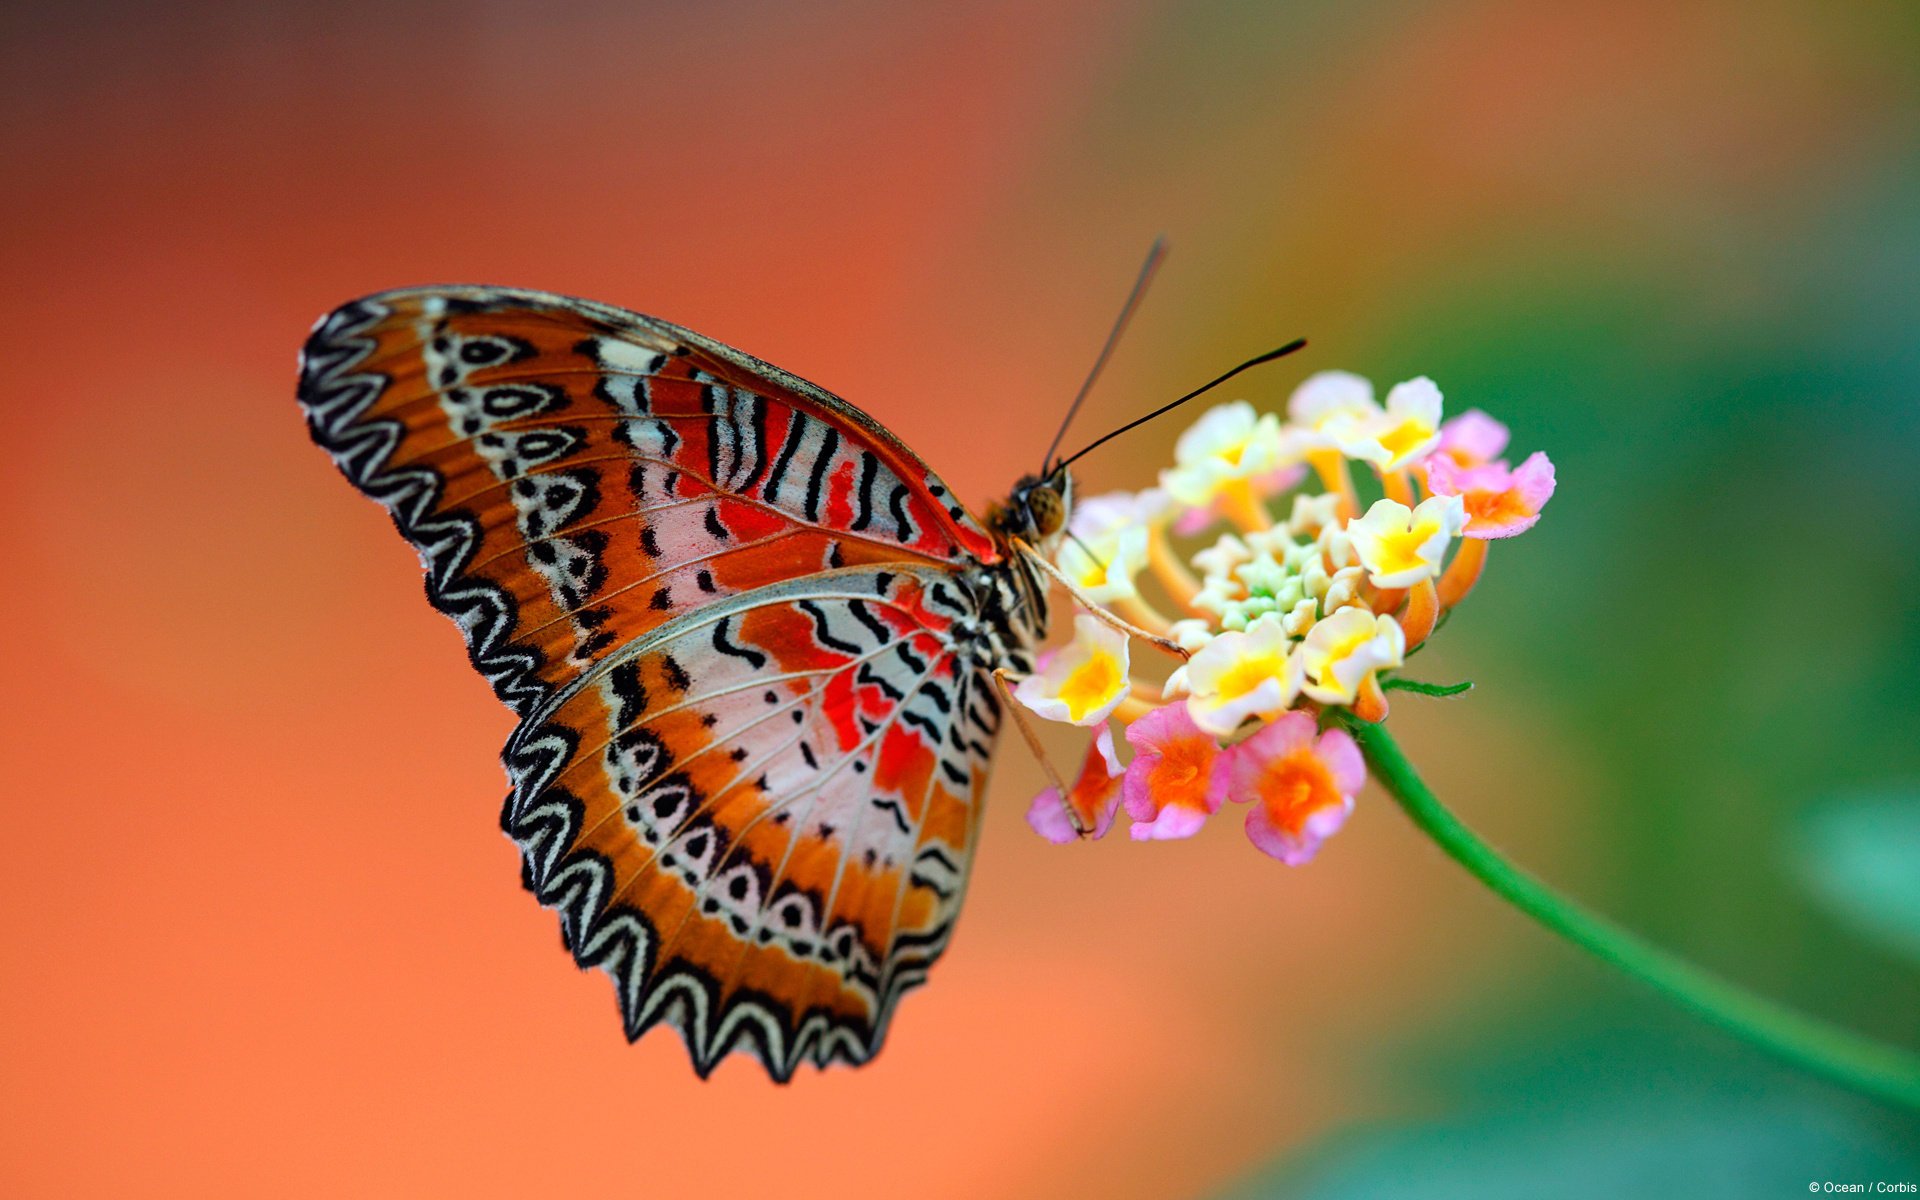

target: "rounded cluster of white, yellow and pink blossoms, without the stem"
[1014,371,1553,864]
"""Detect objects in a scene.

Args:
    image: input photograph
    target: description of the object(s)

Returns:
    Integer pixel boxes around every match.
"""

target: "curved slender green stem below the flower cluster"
[1340,714,1920,1110]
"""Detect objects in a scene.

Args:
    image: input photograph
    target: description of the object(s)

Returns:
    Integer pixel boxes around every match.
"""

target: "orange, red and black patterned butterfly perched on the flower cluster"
[300,286,1071,1081]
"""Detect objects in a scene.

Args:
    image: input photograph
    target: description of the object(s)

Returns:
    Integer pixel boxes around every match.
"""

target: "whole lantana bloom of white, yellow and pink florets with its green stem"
[1006,355,1920,1108]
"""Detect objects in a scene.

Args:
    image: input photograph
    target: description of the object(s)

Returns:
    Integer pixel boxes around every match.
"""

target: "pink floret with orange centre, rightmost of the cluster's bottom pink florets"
[1223,712,1367,866]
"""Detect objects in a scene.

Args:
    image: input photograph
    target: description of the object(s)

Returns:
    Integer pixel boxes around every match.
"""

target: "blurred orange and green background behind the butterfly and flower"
[0,0,1920,1198]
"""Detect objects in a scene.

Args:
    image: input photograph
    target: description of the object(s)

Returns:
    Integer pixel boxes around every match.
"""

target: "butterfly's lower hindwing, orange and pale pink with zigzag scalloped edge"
[503,568,1000,1079]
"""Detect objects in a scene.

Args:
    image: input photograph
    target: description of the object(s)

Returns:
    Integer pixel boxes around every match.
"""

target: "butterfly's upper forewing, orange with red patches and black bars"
[301,288,995,712]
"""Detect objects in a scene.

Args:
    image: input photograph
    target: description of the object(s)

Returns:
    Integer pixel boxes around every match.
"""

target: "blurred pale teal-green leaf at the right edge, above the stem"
[1788,789,1920,960]
